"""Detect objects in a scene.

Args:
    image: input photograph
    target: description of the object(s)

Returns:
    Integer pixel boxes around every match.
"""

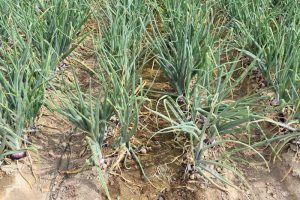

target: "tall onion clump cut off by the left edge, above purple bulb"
[0,24,49,159]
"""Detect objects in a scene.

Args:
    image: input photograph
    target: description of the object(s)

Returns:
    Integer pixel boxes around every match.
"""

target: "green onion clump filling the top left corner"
[1,0,90,65]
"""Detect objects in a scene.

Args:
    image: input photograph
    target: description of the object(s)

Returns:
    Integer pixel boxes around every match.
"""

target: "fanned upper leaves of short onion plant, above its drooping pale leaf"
[50,69,113,152]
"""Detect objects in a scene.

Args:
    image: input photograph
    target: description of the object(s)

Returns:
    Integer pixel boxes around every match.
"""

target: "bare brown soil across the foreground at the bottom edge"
[0,119,300,200]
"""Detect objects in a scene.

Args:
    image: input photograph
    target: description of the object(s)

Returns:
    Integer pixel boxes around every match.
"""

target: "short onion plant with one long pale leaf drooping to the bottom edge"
[47,69,113,199]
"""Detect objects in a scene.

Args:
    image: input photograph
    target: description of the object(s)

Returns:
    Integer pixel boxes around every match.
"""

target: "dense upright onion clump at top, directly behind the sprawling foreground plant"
[149,0,216,95]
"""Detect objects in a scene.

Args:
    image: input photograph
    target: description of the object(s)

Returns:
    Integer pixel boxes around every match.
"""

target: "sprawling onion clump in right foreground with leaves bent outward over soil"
[149,36,293,191]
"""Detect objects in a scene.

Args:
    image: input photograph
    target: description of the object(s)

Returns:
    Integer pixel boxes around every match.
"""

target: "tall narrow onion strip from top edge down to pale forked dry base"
[97,0,152,175]
